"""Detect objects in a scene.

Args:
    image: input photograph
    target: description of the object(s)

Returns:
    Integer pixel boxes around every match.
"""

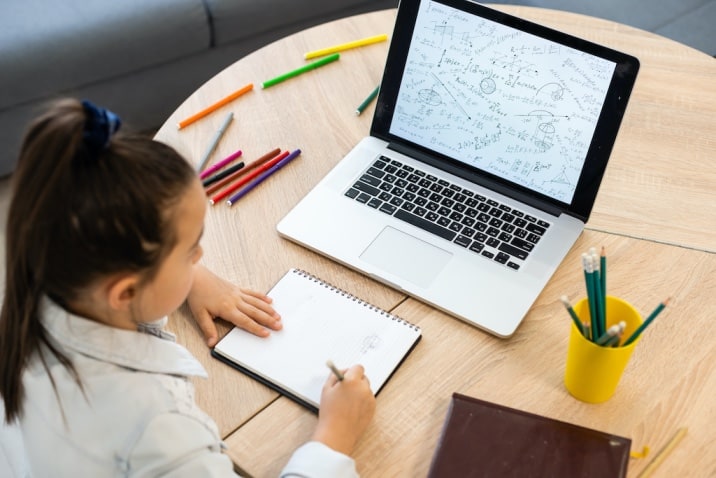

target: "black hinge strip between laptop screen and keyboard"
[388,141,586,218]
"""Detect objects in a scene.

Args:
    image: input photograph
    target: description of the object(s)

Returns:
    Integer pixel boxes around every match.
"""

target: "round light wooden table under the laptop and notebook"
[156,5,716,477]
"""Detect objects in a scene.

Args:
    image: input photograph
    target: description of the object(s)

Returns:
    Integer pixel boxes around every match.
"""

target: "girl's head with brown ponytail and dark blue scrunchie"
[0,100,205,419]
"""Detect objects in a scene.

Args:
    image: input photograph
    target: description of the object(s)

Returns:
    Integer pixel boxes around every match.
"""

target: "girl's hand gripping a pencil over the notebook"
[313,365,375,455]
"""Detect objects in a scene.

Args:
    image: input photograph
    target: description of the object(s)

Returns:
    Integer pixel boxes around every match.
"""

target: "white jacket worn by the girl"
[11,299,357,478]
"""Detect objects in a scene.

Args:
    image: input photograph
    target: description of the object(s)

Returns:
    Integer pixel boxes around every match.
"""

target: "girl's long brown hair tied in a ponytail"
[0,99,196,423]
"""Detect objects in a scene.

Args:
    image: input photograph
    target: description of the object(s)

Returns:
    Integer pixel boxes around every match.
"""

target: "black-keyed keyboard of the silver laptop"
[345,156,550,270]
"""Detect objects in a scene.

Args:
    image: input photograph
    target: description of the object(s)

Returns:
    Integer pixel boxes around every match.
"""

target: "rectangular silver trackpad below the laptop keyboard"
[360,227,452,287]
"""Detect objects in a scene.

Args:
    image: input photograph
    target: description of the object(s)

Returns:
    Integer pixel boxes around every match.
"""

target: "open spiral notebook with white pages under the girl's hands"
[211,269,421,411]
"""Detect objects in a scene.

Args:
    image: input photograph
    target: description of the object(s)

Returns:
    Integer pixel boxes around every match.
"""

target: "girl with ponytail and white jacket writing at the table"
[0,100,375,477]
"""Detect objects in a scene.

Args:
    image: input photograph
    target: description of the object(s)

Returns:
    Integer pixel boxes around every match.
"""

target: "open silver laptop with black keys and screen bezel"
[277,0,639,338]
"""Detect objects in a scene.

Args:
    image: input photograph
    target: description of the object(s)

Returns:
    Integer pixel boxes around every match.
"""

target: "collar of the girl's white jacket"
[40,297,207,378]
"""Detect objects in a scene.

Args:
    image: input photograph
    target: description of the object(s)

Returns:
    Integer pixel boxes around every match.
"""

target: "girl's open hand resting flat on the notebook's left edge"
[187,264,282,347]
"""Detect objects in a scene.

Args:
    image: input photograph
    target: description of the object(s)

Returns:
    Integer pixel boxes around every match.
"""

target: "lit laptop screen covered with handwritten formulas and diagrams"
[390,1,615,203]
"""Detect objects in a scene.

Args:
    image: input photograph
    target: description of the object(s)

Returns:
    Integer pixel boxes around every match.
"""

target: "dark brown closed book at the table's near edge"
[428,393,631,478]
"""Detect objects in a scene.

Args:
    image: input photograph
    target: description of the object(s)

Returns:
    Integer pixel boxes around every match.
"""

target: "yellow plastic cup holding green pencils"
[564,295,642,403]
